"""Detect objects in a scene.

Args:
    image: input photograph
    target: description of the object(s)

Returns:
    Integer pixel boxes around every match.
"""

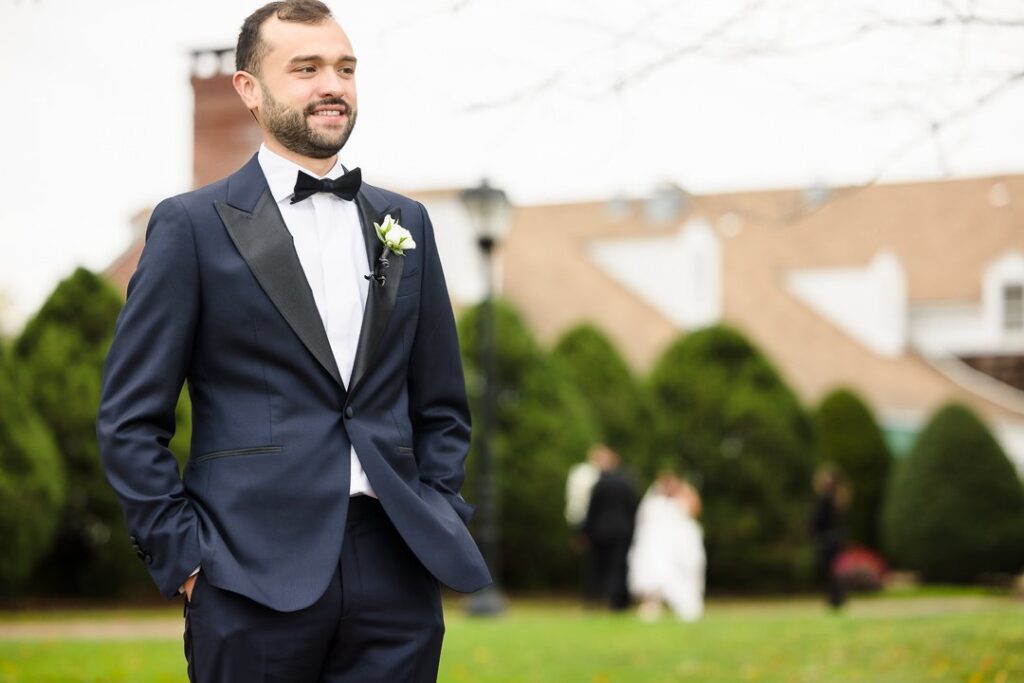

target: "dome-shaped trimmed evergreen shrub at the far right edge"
[883,403,1024,583]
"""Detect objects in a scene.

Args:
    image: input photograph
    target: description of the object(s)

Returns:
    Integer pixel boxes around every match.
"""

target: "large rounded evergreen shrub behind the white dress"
[650,326,815,590]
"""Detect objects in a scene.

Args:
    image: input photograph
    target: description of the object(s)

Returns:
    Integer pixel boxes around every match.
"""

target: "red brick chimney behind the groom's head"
[191,48,262,187]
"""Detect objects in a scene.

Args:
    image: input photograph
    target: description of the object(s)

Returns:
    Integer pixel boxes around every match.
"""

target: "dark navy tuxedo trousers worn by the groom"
[184,497,444,683]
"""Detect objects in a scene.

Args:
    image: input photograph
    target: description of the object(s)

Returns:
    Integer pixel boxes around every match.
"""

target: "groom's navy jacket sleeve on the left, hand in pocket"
[96,200,200,597]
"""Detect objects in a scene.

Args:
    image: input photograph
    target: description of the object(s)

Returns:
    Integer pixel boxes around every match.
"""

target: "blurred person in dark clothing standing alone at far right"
[811,463,850,609]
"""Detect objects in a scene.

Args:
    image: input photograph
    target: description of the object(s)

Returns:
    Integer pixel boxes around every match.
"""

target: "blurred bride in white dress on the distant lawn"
[629,472,706,622]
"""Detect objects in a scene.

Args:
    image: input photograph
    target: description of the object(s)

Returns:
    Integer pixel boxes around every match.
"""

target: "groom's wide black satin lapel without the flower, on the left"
[214,189,344,388]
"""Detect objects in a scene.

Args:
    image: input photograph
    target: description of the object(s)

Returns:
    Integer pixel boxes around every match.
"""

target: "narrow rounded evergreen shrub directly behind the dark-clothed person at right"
[814,389,892,550]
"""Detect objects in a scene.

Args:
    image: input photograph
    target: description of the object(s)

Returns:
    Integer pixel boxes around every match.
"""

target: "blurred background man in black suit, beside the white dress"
[584,445,637,610]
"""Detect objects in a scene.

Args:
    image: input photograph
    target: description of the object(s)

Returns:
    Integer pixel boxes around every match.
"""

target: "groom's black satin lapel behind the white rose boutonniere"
[348,191,406,395]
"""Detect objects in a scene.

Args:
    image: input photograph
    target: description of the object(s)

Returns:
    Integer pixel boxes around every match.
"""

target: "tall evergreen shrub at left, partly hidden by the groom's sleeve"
[15,268,189,595]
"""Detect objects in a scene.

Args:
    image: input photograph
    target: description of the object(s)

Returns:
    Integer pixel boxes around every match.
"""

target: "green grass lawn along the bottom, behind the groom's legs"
[0,595,1024,683]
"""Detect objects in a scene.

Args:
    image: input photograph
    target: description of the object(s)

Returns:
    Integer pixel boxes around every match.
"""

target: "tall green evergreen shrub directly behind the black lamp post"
[459,302,597,589]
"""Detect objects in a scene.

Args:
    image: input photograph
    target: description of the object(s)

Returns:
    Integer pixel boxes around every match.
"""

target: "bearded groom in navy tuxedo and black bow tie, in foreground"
[97,0,489,683]
